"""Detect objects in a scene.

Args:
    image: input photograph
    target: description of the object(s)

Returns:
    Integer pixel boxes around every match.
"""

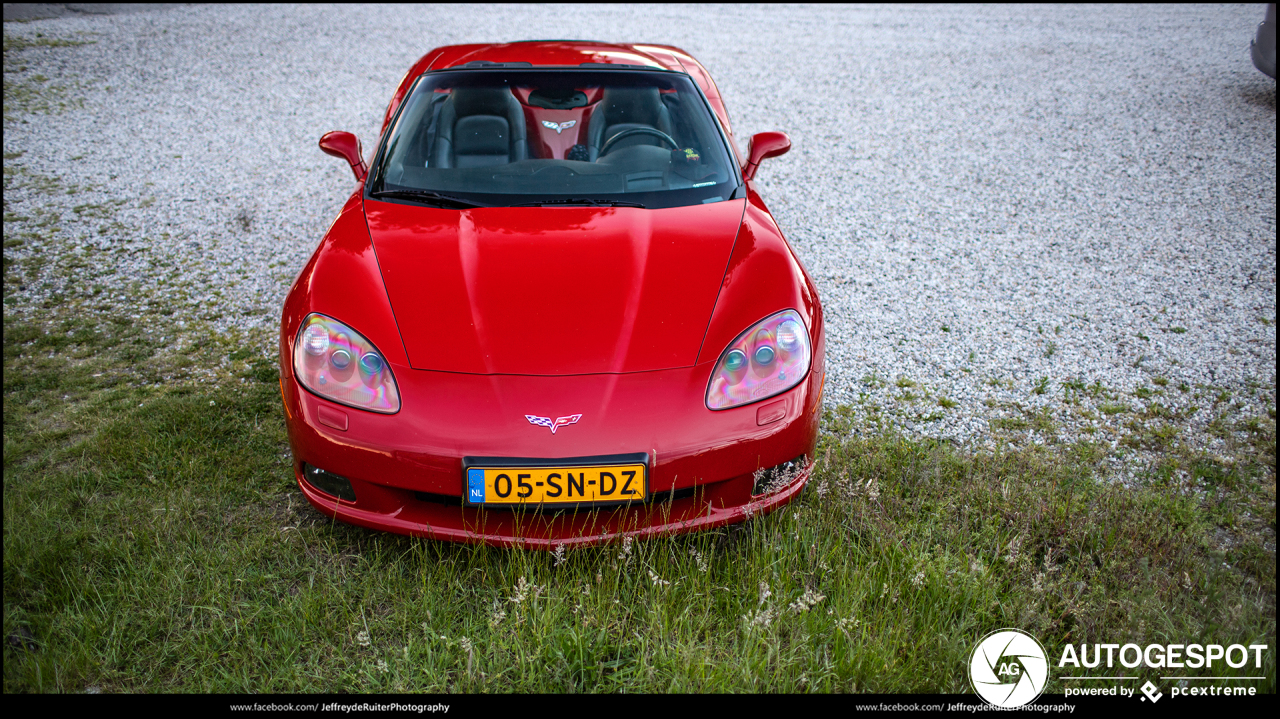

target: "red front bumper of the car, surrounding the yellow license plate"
[282,356,823,549]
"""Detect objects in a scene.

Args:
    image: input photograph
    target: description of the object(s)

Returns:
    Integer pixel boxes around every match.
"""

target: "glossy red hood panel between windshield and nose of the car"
[365,200,745,375]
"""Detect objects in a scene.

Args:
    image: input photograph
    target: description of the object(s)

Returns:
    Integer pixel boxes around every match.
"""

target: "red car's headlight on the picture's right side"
[707,310,810,409]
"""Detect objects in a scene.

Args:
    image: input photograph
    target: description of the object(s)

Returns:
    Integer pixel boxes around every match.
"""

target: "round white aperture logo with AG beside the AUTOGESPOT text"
[969,629,1048,709]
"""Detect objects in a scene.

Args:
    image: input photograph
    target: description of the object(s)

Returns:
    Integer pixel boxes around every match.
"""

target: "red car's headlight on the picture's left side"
[293,313,399,415]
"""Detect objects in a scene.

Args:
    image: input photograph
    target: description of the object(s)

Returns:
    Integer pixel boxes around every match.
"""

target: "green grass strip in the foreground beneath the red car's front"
[4,312,1275,692]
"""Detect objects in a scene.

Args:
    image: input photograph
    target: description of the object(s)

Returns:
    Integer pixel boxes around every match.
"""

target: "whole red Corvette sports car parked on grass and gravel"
[280,41,824,548]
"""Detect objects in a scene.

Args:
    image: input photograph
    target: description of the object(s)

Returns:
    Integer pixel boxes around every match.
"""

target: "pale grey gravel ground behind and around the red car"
[4,5,1276,473]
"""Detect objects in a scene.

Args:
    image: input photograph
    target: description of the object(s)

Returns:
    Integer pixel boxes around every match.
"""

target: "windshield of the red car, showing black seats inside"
[369,69,739,207]
